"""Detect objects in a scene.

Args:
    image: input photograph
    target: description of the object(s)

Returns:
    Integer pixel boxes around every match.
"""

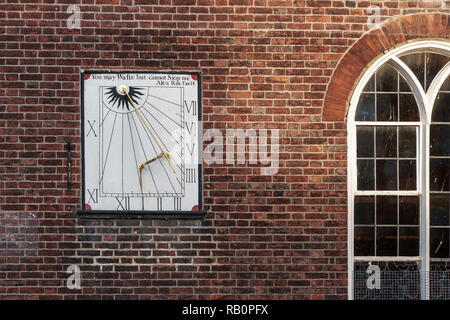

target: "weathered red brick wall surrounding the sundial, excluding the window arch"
[0,0,449,299]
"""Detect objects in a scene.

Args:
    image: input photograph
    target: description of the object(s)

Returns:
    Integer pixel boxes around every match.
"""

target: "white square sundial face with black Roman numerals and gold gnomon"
[83,73,201,211]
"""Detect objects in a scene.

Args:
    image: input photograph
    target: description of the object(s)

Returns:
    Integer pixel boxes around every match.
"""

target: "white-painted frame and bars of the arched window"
[347,40,450,300]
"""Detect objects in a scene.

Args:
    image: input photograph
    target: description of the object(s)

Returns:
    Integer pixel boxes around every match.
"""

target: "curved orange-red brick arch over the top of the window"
[322,13,450,121]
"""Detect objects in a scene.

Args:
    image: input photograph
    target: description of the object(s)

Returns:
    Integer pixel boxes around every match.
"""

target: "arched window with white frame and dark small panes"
[348,41,450,299]
